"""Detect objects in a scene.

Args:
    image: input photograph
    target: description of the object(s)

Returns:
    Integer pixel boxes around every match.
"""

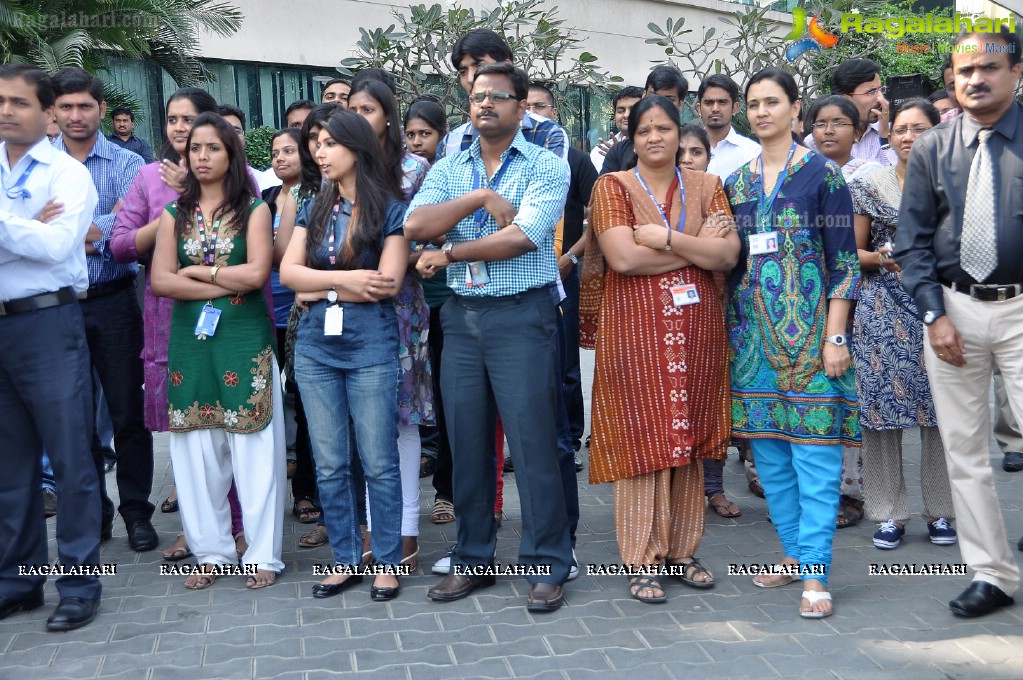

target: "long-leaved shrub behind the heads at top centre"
[338,0,622,114]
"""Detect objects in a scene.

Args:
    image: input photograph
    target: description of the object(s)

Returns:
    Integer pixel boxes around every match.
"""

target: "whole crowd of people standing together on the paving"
[0,23,1023,631]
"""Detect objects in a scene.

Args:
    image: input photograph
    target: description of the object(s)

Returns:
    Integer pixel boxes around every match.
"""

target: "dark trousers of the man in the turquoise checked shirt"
[441,288,572,584]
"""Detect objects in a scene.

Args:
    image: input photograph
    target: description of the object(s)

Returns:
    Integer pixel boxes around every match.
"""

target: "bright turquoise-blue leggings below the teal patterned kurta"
[750,439,842,586]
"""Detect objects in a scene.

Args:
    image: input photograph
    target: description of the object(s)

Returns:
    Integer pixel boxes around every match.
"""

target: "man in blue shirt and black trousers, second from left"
[53,69,159,552]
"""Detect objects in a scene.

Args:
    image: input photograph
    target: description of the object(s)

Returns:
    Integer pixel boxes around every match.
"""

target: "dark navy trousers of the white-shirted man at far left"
[0,304,102,599]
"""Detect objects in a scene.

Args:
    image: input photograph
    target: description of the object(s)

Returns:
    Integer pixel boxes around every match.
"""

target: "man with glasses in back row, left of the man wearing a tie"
[803,59,897,166]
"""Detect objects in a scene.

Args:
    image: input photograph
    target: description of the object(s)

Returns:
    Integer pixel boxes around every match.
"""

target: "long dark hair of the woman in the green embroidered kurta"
[174,111,256,236]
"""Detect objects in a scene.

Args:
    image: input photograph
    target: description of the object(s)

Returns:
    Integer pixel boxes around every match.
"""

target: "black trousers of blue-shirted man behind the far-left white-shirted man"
[79,286,154,524]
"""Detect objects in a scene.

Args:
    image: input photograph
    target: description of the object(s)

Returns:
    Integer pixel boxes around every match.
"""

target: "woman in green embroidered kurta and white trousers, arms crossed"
[152,114,285,589]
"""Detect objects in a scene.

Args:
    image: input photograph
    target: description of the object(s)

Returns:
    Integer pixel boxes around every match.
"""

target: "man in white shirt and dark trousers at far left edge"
[0,63,101,631]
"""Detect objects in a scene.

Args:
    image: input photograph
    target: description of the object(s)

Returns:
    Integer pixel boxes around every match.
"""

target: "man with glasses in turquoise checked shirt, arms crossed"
[405,62,572,611]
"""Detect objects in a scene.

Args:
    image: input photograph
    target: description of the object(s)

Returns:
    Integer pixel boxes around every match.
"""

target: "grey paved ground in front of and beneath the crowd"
[0,353,1023,680]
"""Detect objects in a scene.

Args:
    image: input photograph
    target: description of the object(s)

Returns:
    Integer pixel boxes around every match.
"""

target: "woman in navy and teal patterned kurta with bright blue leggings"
[725,69,859,618]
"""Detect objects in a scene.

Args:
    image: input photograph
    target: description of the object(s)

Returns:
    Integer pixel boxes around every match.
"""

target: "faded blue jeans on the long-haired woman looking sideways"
[295,353,401,566]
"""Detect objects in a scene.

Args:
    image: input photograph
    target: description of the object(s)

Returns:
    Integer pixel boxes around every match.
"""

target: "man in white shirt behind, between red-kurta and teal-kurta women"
[697,74,760,182]
